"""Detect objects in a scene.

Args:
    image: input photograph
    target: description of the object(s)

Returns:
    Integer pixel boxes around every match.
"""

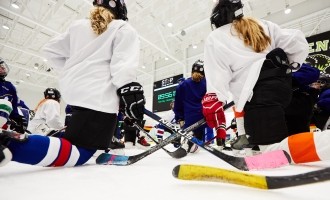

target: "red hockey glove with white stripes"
[202,93,226,139]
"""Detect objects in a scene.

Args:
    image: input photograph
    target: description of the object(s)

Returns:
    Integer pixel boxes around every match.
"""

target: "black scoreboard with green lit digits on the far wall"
[152,74,183,112]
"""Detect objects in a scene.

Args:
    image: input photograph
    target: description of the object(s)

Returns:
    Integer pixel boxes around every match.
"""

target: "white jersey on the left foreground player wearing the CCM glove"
[43,19,140,113]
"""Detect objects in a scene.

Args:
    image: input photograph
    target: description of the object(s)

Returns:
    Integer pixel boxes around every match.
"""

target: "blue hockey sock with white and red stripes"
[8,135,96,167]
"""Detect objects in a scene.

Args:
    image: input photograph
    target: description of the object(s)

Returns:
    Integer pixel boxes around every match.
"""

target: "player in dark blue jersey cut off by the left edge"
[0,58,26,133]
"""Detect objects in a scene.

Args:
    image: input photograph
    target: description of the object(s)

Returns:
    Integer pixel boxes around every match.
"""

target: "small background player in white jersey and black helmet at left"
[28,88,64,135]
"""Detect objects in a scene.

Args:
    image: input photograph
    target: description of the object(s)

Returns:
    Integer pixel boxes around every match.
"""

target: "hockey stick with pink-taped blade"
[145,105,291,171]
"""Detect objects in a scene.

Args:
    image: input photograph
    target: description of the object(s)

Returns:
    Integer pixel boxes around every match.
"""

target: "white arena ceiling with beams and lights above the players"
[0,0,330,99]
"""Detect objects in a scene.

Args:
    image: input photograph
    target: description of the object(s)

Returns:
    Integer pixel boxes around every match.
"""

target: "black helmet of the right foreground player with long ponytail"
[210,0,243,28]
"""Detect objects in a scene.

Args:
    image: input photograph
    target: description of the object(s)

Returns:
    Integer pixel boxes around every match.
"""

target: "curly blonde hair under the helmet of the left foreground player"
[89,6,115,35]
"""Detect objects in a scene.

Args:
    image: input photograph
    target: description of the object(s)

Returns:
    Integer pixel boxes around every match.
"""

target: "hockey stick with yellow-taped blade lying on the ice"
[172,165,330,190]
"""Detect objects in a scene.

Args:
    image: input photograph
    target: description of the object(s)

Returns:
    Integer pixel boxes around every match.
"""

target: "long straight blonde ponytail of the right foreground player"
[233,17,271,53]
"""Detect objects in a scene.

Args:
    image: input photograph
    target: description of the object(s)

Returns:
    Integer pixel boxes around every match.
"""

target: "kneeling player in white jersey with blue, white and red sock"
[0,0,145,166]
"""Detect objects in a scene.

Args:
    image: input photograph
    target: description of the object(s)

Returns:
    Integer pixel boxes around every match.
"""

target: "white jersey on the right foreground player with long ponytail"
[204,20,309,112]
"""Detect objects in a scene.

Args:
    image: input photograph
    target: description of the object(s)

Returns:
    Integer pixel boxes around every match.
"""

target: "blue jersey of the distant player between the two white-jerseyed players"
[173,78,206,128]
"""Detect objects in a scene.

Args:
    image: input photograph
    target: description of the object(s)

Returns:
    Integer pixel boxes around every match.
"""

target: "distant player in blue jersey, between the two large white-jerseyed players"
[173,60,220,152]
